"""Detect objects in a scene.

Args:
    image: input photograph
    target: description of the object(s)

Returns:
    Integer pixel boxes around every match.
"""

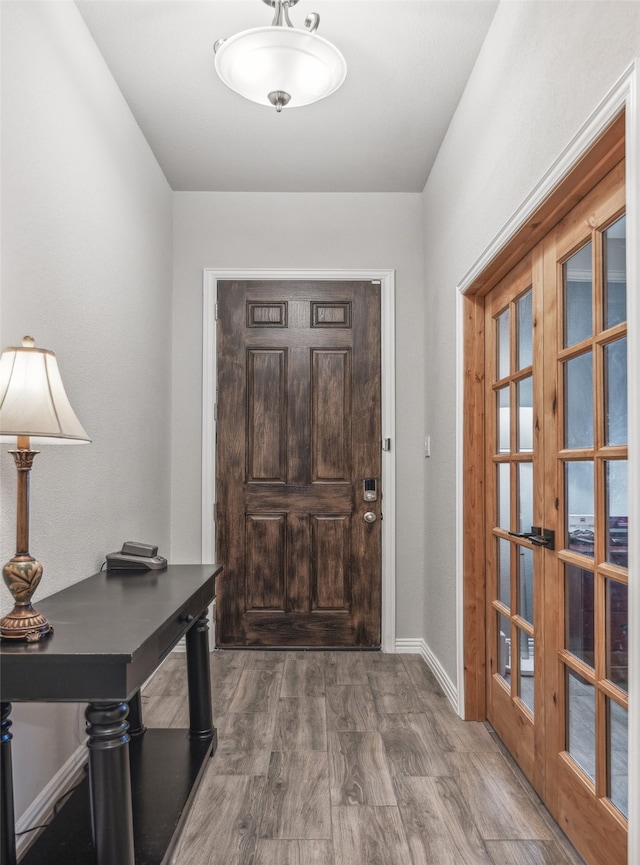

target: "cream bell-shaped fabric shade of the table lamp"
[0,336,91,445]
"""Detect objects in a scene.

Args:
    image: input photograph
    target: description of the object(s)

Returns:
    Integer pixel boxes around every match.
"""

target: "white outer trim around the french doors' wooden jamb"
[456,59,640,865]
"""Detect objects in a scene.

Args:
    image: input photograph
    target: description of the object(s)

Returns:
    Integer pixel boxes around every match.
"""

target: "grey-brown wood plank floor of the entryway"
[143,651,584,865]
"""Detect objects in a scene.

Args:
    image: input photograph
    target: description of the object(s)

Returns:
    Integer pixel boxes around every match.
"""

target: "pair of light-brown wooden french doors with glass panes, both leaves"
[485,163,628,865]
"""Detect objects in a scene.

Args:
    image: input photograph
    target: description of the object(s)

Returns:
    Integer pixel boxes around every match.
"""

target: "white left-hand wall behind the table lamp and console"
[0,2,172,816]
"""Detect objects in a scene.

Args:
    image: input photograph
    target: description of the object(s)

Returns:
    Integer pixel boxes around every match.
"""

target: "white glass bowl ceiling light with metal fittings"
[213,0,347,112]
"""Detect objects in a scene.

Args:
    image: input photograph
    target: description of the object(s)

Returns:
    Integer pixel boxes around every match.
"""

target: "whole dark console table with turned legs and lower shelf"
[0,565,221,865]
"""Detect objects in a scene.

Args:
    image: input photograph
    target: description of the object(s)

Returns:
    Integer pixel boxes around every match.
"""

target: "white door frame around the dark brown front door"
[202,267,396,652]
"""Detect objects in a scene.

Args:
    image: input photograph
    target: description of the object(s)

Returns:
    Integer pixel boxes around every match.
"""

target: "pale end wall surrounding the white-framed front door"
[171,192,425,638]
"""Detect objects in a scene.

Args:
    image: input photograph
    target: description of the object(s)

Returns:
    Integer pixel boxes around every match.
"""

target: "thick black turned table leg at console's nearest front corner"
[85,702,135,865]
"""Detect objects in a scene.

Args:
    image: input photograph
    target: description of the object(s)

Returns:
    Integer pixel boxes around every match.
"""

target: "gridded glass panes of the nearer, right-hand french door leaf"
[556,191,632,855]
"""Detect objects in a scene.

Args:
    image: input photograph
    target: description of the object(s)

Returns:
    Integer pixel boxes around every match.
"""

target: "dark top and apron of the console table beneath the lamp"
[0,564,222,702]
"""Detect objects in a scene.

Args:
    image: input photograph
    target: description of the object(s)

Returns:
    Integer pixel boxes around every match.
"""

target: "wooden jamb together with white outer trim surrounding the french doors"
[458,61,640,863]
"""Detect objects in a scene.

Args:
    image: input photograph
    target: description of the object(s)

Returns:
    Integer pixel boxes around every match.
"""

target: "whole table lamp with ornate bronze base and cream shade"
[0,336,90,642]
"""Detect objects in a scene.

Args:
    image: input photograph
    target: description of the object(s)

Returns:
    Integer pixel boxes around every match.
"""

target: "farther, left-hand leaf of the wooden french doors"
[485,249,545,793]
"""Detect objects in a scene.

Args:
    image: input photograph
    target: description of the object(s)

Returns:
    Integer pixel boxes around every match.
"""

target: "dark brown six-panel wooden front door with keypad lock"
[216,280,382,647]
